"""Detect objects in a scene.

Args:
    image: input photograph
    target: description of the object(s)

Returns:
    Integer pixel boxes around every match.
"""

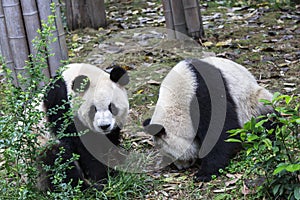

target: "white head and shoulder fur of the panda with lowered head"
[151,61,199,168]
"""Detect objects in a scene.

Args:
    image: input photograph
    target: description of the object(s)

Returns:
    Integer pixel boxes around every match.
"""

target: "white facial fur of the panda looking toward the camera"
[63,64,129,134]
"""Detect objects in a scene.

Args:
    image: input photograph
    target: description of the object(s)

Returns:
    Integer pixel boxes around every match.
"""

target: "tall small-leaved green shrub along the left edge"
[0,4,77,199]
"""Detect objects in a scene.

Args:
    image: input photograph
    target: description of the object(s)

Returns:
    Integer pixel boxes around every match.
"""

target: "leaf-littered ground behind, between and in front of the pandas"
[68,1,300,199]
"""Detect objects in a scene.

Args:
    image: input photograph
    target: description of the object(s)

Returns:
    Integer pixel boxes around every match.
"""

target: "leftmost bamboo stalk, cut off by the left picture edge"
[0,0,19,86]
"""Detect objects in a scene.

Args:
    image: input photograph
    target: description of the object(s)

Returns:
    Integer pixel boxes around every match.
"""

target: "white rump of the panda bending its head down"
[202,57,273,126]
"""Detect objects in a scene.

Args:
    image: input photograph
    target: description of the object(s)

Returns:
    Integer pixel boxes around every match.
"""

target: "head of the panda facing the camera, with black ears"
[63,64,129,134]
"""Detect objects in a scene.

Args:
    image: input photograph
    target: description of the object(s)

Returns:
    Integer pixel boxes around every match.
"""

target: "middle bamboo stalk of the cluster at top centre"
[171,0,187,39]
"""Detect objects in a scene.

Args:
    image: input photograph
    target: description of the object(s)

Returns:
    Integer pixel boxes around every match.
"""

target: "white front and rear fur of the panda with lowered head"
[150,57,272,169]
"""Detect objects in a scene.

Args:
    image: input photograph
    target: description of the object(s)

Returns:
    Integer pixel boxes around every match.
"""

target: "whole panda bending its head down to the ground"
[143,57,273,182]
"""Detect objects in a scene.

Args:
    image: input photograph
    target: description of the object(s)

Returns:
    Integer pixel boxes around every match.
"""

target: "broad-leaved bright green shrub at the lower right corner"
[229,93,300,199]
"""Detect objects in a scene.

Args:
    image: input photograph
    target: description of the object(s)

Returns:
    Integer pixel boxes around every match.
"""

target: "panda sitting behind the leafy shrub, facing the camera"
[37,63,129,190]
